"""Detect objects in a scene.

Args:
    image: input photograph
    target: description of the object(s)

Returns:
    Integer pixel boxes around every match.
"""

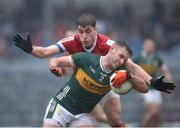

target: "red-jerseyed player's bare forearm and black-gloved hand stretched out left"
[13,34,59,58]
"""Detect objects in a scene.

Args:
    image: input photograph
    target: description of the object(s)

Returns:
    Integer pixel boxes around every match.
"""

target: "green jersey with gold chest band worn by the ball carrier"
[54,52,122,115]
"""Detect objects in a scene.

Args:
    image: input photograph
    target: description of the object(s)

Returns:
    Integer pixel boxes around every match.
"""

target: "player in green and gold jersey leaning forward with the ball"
[45,42,152,126]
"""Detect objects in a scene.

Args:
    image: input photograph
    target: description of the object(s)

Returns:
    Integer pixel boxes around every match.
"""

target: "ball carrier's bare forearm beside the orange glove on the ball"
[130,74,149,93]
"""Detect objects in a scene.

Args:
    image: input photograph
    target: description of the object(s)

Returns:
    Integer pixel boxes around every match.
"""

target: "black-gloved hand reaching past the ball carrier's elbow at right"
[150,76,176,93]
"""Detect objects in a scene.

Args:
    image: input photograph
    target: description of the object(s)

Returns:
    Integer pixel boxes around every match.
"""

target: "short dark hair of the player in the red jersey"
[76,14,96,27]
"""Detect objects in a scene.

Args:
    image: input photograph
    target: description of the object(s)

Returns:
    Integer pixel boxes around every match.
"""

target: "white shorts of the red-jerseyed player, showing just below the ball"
[99,90,120,108]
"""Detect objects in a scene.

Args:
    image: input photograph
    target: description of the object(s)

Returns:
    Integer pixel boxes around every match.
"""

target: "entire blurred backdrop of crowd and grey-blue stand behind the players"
[0,0,180,126]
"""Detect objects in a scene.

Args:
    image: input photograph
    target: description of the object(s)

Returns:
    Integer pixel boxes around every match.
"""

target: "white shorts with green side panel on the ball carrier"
[44,99,93,127]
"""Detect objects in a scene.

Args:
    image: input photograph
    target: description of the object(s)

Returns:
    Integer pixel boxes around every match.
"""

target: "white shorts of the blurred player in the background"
[142,89,162,104]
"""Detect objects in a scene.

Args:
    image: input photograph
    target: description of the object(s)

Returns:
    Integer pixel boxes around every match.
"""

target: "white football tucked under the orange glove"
[110,73,132,95]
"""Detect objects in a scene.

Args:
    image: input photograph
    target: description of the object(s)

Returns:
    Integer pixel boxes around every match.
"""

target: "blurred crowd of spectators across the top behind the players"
[0,0,180,59]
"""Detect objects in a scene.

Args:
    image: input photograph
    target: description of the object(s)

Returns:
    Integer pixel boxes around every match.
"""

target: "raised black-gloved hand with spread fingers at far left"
[13,34,33,53]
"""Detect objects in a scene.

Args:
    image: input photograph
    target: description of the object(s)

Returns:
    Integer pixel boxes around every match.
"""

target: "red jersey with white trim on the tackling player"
[56,34,114,55]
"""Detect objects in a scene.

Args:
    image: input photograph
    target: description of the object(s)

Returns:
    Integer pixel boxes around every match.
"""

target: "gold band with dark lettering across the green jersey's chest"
[76,68,111,95]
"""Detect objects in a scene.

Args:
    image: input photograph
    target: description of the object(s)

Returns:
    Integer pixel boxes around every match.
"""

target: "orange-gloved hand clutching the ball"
[111,70,131,88]
